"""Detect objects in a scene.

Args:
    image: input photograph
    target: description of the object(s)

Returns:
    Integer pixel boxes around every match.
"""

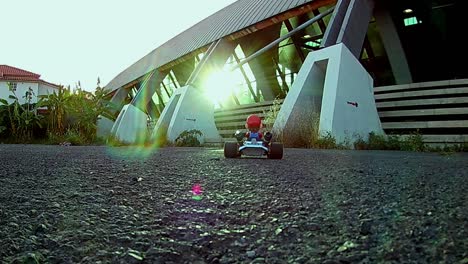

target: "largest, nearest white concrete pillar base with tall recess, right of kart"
[273,43,384,144]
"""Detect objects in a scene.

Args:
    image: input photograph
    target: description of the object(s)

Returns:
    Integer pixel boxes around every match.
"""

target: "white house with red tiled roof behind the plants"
[0,65,59,104]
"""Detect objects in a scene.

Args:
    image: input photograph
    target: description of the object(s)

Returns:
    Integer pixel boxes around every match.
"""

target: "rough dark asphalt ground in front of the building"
[0,145,468,264]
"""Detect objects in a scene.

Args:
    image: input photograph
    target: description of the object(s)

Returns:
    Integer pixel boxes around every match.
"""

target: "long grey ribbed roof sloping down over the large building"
[106,0,325,90]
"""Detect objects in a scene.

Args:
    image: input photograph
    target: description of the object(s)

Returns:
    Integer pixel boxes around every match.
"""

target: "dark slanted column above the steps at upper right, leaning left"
[374,2,413,84]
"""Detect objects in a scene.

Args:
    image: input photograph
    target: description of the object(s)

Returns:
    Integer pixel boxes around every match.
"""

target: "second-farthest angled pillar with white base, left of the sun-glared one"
[111,71,166,144]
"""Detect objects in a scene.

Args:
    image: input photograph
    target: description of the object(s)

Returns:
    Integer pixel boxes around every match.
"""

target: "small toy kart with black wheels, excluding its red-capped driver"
[224,131,283,159]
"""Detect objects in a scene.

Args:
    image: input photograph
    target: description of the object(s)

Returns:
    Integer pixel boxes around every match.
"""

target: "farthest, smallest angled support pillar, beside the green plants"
[96,88,130,138]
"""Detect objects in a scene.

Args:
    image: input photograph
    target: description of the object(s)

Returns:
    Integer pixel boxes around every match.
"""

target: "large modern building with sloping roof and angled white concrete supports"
[99,0,468,144]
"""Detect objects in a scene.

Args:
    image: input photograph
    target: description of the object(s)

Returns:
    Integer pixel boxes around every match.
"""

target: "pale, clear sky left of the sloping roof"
[0,0,236,92]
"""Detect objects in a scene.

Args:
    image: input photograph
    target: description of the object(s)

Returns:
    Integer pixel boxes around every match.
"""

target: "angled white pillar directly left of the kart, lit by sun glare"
[152,39,235,144]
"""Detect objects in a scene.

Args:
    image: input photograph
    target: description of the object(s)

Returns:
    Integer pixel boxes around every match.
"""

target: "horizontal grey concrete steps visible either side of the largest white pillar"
[215,79,468,147]
